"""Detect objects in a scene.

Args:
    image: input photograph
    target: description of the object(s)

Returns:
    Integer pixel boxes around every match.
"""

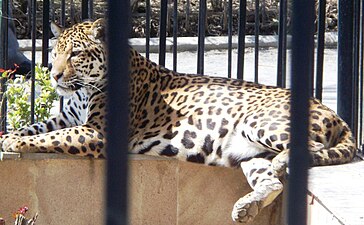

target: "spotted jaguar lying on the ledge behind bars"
[1,19,357,223]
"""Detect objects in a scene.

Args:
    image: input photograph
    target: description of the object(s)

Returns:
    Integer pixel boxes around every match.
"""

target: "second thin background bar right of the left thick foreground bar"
[159,0,168,66]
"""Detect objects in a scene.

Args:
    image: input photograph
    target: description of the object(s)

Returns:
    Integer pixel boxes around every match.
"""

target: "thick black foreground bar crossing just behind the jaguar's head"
[105,0,130,225]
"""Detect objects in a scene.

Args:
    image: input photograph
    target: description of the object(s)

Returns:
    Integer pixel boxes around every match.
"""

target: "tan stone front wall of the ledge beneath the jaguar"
[0,154,282,225]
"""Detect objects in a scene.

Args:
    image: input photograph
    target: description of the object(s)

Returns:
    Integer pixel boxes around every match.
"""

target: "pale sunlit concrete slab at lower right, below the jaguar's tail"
[308,161,364,225]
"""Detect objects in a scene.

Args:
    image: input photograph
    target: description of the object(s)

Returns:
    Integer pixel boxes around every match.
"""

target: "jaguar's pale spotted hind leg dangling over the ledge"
[232,158,283,223]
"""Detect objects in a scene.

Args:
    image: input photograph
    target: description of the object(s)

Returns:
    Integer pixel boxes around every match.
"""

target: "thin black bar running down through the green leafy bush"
[30,0,37,124]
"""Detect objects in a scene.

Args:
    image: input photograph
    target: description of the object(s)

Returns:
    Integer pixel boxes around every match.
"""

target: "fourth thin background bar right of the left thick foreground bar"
[197,0,206,74]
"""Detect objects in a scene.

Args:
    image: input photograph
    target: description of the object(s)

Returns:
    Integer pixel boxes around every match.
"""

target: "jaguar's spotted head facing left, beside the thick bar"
[50,19,107,96]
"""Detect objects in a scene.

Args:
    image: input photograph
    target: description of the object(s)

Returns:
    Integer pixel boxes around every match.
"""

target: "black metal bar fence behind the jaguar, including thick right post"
[0,0,363,148]
